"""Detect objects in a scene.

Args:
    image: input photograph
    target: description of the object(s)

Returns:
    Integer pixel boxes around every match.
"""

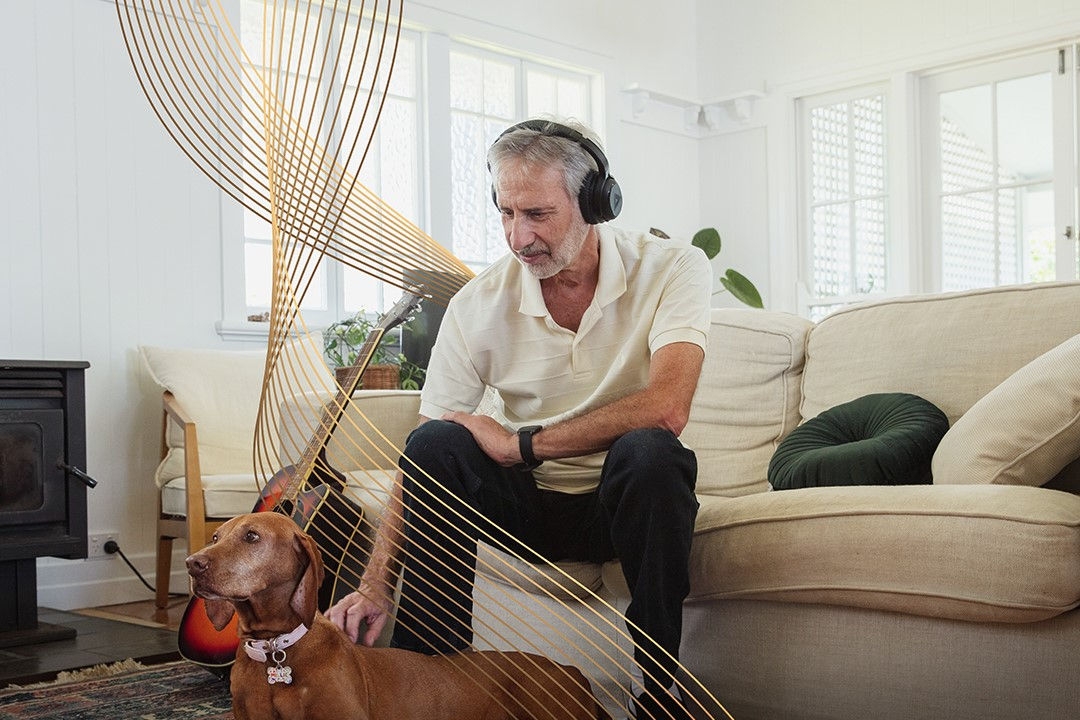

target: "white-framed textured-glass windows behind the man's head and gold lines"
[225,8,599,331]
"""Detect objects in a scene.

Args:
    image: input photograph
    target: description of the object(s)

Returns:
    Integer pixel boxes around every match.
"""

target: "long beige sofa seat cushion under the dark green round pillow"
[690,485,1080,622]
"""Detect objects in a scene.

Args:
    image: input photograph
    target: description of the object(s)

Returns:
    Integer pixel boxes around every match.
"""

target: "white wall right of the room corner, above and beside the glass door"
[696,0,1080,311]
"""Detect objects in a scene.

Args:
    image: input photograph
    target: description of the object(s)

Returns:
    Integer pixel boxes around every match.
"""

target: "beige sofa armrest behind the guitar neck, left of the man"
[279,390,420,473]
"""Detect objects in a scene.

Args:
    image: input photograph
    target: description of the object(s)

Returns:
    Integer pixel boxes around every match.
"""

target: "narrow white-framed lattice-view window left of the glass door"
[800,89,889,320]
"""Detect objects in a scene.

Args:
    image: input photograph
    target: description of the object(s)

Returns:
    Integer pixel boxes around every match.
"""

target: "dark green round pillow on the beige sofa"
[769,393,948,490]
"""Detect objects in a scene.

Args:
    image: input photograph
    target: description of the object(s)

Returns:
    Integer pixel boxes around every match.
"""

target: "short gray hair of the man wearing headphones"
[487,118,603,204]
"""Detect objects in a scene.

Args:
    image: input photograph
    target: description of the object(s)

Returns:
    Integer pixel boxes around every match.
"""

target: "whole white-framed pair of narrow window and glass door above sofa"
[788,46,1080,320]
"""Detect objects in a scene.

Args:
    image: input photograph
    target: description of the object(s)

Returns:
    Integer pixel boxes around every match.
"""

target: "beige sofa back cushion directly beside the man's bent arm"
[680,309,811,495]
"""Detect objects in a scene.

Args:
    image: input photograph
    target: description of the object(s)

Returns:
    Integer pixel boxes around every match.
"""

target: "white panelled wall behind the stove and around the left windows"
[0,0,698,609]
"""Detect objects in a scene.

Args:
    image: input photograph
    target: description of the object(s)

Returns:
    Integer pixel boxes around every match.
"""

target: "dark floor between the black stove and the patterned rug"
[0,597,188,689]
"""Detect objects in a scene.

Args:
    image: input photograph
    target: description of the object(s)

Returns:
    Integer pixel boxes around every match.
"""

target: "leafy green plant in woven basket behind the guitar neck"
[323,309,424,390]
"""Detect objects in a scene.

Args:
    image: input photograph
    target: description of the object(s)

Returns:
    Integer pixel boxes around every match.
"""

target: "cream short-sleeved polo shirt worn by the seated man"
[420,226,713,493]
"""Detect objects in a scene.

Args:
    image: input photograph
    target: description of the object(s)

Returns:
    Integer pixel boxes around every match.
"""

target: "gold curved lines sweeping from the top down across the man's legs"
[116,0,731,718]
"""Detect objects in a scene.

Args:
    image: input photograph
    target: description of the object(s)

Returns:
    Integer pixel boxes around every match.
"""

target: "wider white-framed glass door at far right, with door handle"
[922,51,1075,290]
